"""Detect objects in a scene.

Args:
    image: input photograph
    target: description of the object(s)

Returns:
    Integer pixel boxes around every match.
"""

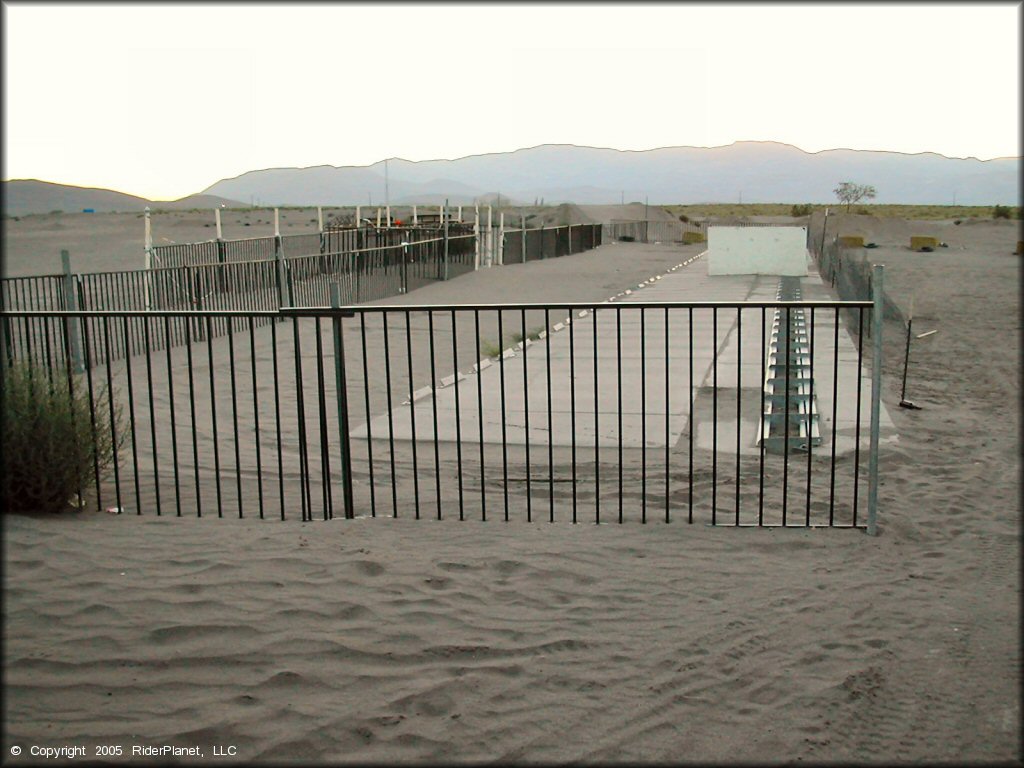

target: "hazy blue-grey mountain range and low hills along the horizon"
[3,141,1021,215]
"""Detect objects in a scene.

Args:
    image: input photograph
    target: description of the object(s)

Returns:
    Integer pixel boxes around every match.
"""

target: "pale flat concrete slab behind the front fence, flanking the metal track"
[353,254,895,455]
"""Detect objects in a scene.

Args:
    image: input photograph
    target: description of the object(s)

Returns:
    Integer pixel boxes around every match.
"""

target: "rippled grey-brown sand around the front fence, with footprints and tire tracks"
[4,217,1021,765]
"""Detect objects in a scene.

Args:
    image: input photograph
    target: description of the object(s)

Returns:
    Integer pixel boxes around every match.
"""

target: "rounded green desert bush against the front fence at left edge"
[0,362,126,512]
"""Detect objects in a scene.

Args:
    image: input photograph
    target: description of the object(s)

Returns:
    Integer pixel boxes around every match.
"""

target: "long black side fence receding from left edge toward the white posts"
[0,230,476,370]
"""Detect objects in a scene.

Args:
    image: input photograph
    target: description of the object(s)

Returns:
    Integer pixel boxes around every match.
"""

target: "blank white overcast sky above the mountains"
[3,2,1022,200]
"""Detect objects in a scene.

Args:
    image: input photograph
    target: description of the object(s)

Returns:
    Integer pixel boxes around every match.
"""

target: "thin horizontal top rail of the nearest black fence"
[0,301,874,317]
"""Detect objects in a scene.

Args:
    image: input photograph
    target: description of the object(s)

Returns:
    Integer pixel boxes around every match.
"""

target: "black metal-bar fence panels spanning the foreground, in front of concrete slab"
[0,302,878,527]
